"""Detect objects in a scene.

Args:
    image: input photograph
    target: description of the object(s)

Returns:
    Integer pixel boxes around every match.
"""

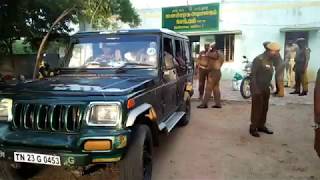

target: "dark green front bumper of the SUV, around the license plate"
[0,125,131,167]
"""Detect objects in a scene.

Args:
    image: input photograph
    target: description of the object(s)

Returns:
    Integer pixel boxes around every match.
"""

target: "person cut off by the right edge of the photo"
[314,69,320,157]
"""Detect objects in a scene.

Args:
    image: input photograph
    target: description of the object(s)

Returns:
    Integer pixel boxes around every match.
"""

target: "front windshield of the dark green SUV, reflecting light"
[67,35,158,68]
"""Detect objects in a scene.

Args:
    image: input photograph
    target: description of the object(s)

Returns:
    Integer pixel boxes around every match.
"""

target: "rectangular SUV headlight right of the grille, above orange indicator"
[87,102,121,126]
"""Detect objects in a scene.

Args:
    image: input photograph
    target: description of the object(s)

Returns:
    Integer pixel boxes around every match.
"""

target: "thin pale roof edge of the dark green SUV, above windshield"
[73,29,188,39]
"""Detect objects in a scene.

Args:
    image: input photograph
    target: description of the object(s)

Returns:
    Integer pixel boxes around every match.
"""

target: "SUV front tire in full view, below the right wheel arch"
[119,125,153,180]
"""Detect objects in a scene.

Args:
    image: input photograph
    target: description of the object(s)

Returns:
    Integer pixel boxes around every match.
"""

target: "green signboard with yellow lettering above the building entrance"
[162,3,220,32]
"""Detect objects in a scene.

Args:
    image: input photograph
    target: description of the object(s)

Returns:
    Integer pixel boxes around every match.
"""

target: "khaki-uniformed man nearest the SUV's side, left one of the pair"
[197,44,210,100]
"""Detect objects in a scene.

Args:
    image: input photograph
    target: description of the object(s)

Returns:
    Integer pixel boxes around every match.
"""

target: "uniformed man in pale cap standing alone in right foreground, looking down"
[249,42,280,137]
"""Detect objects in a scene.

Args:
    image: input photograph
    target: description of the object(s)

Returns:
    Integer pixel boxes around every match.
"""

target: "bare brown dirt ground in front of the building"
[30,102,320,180]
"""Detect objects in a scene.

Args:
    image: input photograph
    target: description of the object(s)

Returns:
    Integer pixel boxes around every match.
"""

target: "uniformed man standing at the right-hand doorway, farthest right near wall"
[290,38,311,96]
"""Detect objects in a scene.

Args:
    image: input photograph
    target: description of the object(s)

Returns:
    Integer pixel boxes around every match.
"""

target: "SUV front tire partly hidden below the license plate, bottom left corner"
[0,161,39,180]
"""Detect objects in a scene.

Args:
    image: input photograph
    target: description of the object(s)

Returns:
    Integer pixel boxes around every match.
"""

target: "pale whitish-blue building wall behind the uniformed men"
[139,0,320,80]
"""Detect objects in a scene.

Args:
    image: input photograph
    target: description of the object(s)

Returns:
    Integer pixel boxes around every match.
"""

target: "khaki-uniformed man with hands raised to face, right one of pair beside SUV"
[198,43,224,108]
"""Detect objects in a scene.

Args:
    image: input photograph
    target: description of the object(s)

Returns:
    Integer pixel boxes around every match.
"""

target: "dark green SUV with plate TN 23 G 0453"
[0,29,193,180]
